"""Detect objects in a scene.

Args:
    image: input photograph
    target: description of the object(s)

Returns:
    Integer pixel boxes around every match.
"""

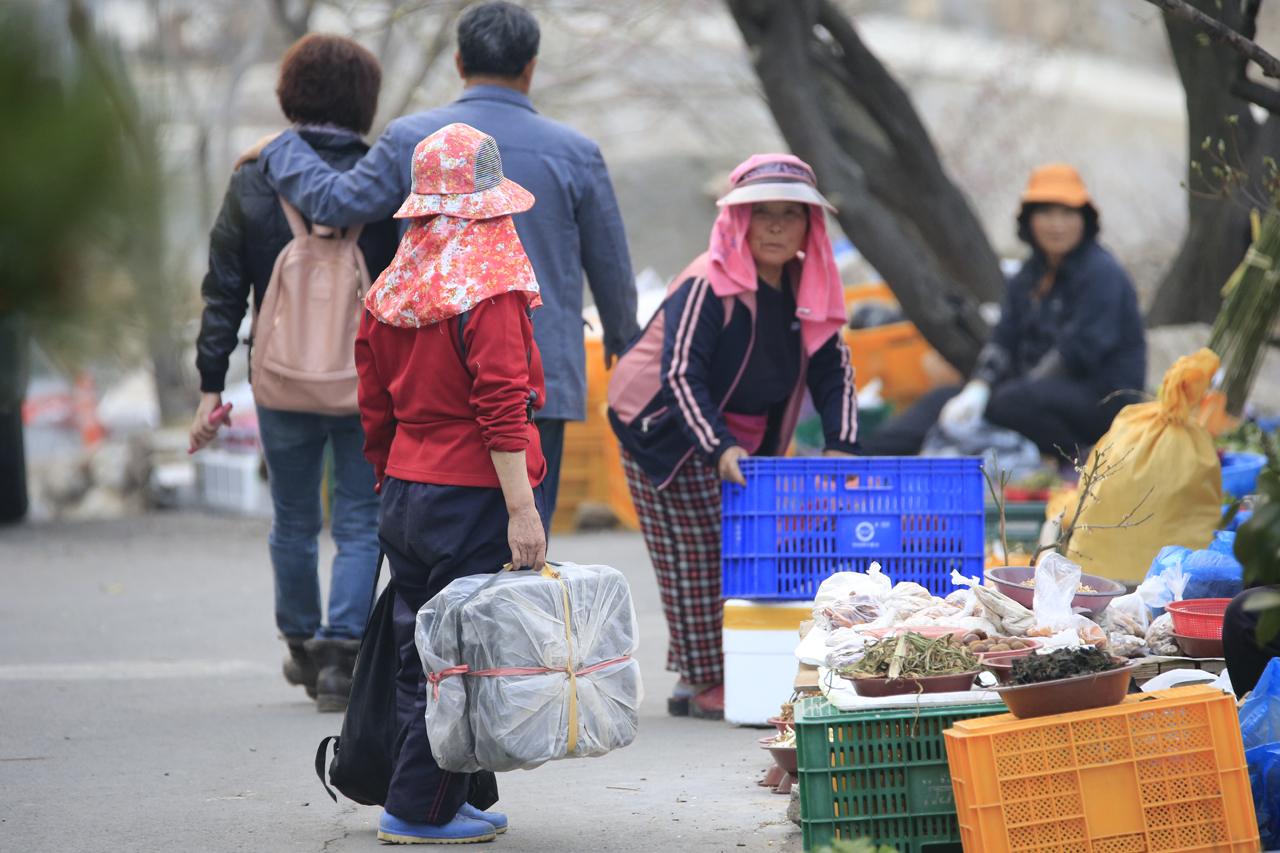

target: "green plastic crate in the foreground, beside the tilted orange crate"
[795,697,1006,853]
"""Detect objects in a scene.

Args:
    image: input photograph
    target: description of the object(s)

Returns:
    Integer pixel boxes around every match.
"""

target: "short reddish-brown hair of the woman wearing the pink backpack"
[275,33,383,134]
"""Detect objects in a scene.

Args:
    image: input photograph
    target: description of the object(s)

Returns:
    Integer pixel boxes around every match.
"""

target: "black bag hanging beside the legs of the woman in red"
[316,553,498,809]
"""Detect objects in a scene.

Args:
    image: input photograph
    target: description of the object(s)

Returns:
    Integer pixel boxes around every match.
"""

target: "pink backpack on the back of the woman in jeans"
[250,199,370,415]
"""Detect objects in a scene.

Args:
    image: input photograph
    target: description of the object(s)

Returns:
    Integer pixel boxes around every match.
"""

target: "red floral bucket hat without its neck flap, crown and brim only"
[396,123,534,219]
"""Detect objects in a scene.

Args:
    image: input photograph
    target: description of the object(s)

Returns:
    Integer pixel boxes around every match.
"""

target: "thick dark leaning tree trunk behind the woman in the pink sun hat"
[727,0,1004,373]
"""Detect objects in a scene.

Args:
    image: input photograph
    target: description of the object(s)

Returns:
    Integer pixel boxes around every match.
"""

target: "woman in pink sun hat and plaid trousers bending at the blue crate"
[609,154,858,719]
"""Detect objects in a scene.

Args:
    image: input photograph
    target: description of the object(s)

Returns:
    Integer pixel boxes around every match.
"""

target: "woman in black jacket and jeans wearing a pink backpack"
[191,33,399,711]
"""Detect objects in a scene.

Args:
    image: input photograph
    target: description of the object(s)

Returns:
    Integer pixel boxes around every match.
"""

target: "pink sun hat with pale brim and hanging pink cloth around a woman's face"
[707,154,847,355]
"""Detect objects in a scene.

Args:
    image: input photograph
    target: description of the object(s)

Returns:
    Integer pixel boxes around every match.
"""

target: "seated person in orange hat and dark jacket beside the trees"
[860,163,1147,462]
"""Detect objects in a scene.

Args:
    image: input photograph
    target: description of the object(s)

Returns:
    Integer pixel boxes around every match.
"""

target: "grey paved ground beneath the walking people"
[0,514,800,853]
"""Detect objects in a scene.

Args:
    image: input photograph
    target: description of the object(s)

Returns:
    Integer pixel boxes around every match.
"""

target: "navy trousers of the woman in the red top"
[378,476,548,826]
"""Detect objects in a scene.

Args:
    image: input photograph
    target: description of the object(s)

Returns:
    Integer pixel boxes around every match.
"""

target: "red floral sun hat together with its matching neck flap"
[365,124,543,328]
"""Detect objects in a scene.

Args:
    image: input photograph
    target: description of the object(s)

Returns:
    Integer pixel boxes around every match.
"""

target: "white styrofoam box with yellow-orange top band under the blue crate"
[723,598,813,726]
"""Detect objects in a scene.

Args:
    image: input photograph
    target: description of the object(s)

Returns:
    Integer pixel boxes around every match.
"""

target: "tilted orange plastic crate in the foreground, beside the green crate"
[945,685,1261,853]
